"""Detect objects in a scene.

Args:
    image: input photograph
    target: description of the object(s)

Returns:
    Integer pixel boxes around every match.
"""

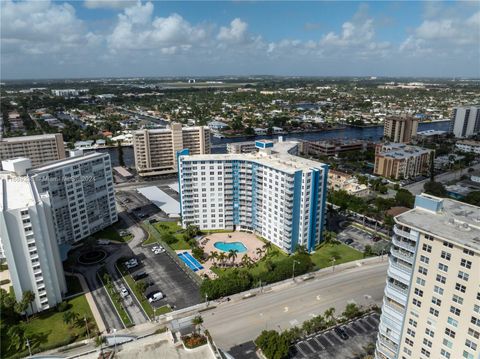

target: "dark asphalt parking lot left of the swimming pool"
[127,244,201,309]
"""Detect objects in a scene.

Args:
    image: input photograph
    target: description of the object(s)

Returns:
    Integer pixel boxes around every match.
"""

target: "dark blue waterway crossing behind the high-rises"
[90,121,450,167]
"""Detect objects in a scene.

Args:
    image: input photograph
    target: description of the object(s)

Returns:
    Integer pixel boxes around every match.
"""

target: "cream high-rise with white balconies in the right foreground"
[375,194,480,359]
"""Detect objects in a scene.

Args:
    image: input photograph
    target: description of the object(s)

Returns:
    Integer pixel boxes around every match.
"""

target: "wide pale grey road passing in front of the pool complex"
[202,260,387,350]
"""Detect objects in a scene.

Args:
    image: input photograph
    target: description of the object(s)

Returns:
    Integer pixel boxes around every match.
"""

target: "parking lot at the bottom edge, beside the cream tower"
[289,313,380,359]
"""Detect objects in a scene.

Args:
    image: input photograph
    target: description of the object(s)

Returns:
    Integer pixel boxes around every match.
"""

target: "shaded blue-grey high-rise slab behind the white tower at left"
[28,152,118,244]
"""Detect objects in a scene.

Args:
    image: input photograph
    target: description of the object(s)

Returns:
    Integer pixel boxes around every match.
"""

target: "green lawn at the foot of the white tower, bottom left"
[2,295,96,358]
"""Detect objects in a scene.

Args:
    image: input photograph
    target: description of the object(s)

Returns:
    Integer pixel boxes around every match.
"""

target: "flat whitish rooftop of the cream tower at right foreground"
[395,194,480,252]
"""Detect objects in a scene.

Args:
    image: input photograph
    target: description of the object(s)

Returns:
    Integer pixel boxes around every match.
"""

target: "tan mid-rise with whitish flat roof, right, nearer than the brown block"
[373,143,434,180]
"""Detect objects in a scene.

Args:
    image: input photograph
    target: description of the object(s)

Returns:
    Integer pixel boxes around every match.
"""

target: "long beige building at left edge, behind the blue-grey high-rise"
[0,133,66,167]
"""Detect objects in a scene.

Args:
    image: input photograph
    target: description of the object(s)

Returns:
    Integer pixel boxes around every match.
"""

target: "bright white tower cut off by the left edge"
[0,173,67,312]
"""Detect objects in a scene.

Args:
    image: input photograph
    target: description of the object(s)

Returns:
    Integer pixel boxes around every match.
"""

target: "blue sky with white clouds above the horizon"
[0,0,480,80]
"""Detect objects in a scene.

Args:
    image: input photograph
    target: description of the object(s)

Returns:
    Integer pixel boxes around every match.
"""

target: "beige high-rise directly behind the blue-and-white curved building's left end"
[133,123,210,176]
